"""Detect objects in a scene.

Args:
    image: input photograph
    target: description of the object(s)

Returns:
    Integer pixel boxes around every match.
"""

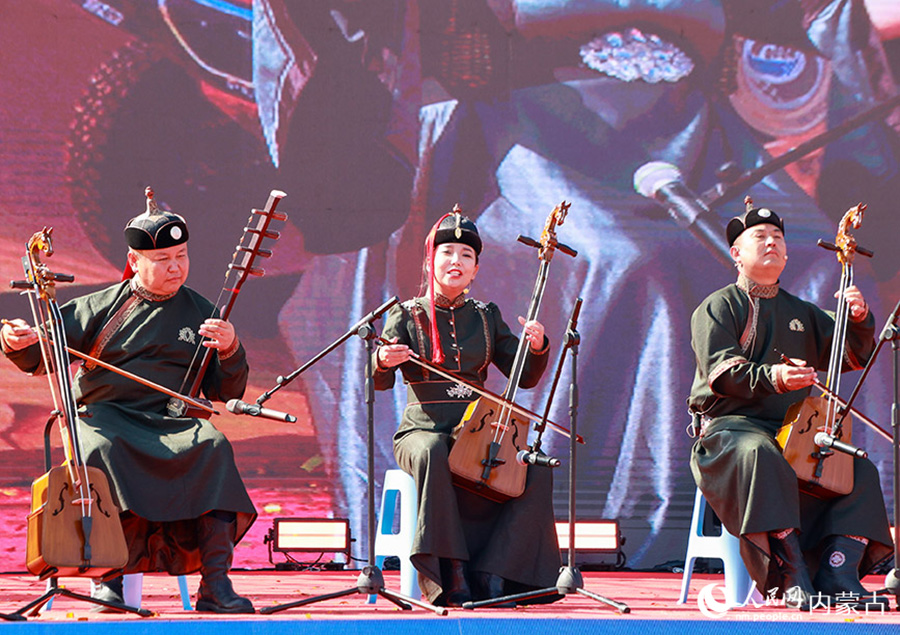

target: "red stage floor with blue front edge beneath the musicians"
[0,571,900,635]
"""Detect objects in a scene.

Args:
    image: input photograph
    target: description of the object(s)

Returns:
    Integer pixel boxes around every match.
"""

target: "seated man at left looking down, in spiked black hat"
[0,188,256,613]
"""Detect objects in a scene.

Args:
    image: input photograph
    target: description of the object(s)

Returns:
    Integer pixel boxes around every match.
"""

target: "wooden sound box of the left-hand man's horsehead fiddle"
[26,467,128,579]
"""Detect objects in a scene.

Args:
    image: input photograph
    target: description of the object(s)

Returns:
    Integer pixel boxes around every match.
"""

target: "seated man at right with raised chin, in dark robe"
[688,205,892,609]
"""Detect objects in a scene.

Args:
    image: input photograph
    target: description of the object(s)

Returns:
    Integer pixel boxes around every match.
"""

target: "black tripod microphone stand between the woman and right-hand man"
[462,298,631,614]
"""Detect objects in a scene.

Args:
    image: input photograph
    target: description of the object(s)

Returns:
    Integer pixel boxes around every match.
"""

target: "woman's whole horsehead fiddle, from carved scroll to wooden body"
[449,201,576,502]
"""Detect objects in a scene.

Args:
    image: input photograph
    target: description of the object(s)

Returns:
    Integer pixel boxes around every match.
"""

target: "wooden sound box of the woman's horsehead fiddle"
[450,397,528,503]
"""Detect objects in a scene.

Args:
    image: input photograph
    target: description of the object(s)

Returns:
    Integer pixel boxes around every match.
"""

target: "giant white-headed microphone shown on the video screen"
[634,161,733,268]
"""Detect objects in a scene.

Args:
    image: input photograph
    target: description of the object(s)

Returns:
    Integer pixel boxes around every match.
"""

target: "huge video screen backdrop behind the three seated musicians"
[0,0,900,570]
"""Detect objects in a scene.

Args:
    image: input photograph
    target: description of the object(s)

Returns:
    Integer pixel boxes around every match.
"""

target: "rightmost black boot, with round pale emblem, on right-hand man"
[813,536,890,610]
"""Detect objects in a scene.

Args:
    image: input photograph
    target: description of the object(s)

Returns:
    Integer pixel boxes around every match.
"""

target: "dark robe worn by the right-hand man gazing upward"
[688,276,893,590]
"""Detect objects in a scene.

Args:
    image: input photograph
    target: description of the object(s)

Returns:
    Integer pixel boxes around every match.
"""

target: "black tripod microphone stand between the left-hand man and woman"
[257,296,447,615]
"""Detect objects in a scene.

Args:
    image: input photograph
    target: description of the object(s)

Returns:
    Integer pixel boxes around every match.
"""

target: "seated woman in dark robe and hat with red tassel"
[374,212,560,606]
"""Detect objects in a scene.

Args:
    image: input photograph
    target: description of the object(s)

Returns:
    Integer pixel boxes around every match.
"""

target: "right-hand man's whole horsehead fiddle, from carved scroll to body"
[776,203,872,498]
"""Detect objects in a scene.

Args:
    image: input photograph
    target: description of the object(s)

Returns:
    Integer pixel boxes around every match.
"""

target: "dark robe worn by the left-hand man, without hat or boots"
[7,282,256,575]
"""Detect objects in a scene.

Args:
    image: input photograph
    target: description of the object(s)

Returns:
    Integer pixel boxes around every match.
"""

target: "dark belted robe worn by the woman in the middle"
[375,298,560,602]
